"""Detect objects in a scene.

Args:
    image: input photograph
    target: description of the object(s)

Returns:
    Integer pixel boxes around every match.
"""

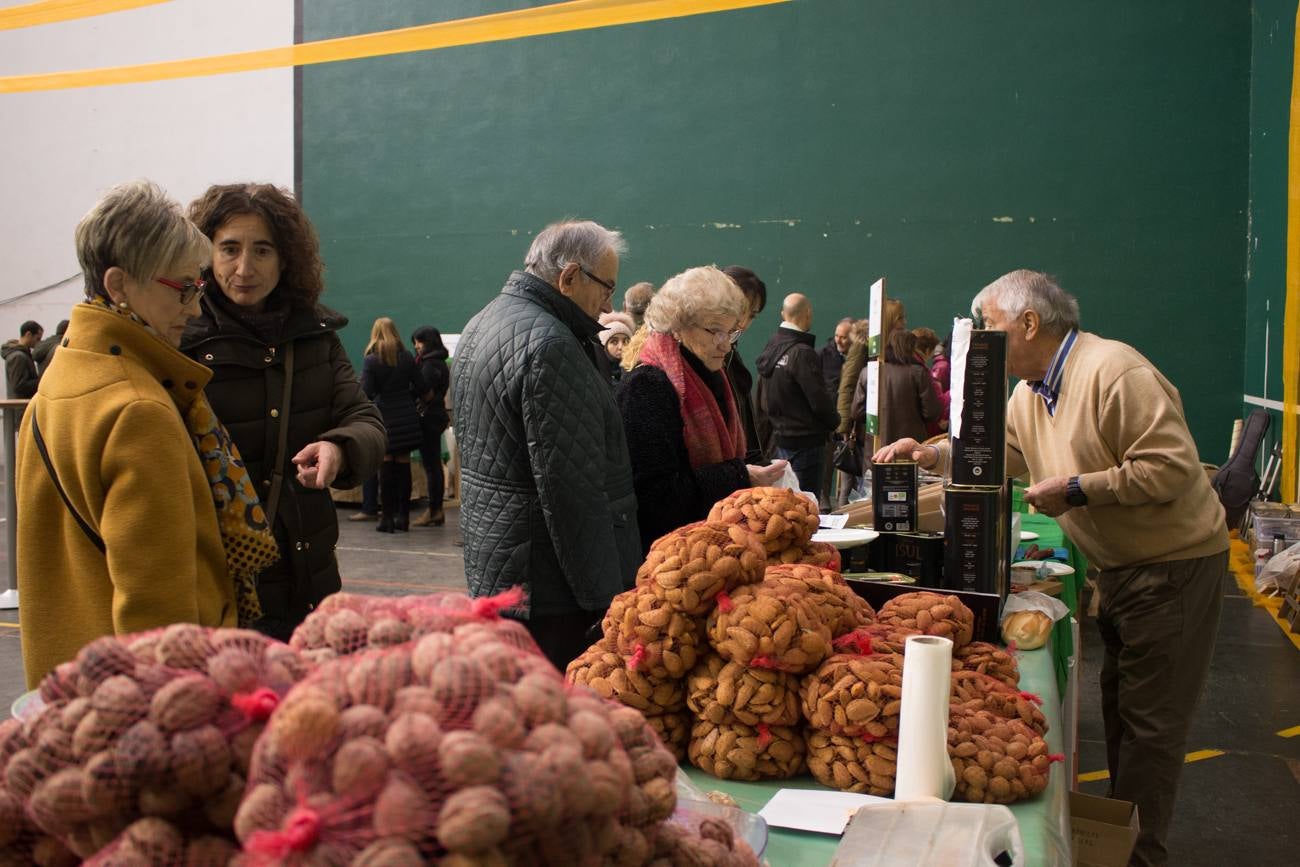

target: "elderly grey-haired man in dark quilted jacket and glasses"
[451,222,641,669]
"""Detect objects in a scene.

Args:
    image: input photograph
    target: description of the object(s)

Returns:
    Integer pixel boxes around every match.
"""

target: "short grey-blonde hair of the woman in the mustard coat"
[74,181,212,300]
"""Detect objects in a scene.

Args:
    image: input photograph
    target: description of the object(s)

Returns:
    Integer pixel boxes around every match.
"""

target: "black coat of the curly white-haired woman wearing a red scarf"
[616,365,749,550]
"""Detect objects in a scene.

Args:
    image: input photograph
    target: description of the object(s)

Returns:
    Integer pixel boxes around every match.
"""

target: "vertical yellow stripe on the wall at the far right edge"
[1281,9,1300,504]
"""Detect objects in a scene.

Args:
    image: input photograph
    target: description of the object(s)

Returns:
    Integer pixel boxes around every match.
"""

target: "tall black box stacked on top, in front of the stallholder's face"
[949,330,1006,485]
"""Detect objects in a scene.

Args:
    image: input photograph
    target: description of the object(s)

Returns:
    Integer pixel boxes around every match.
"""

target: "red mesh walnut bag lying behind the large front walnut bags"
[289,588,533,662]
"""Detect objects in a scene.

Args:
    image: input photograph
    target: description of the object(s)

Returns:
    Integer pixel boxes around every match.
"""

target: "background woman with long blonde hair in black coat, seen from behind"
[361,316,429,533]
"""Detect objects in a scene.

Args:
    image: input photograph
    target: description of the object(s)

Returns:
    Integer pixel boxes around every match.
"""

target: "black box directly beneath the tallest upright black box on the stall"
[944,486,1010,598]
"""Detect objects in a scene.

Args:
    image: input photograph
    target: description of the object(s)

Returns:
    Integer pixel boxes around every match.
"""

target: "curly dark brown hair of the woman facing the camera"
[190,183,325,307]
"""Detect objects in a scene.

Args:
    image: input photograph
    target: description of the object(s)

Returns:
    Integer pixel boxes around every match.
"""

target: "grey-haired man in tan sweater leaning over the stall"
[875,270,1227,867]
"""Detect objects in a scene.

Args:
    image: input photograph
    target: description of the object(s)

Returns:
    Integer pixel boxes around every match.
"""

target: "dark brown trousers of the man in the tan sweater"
[1097,551,1227,867]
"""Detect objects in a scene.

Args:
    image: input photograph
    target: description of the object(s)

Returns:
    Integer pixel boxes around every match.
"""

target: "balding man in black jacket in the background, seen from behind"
[758,292,840,498]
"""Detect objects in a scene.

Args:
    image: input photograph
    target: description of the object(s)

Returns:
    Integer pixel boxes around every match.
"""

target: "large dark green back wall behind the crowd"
[300,0,1252,461]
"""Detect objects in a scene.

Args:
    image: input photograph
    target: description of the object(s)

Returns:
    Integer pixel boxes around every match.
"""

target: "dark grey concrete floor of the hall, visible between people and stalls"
[0,507,1300,867]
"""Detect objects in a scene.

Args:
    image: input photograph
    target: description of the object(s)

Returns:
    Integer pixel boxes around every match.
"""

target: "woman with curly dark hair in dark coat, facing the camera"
[181,183,384,640]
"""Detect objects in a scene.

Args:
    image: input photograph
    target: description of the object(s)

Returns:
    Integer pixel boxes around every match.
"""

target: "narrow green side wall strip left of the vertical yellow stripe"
[1243,0,1296,467]
